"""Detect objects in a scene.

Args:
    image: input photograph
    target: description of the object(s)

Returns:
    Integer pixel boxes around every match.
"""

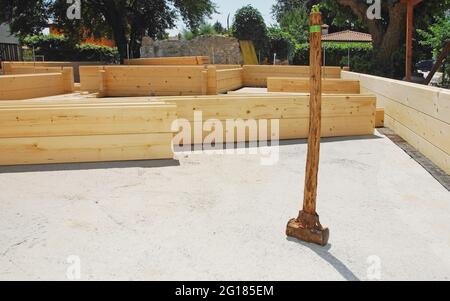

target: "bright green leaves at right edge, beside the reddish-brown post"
[417,16,450,57]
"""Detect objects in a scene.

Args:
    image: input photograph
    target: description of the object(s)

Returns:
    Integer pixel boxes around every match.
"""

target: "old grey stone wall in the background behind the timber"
[141,36,243,64]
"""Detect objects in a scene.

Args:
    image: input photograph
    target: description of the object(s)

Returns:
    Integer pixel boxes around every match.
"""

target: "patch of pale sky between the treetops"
[169,0,276,36]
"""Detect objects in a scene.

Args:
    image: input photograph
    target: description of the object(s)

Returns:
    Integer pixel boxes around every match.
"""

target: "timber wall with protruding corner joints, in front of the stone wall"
[80,65,248,97]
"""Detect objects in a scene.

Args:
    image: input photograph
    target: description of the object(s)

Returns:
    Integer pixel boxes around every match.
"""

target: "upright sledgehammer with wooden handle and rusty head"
[286,12,329,246]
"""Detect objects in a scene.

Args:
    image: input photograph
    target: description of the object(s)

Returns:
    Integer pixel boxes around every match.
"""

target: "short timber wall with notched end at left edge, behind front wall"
[0,68,74,101]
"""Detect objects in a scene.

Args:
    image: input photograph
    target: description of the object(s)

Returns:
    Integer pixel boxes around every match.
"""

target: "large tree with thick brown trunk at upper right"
[273,0,450,77]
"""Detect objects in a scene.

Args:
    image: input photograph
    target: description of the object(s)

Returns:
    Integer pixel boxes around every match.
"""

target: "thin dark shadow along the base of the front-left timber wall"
[0,160,180,174]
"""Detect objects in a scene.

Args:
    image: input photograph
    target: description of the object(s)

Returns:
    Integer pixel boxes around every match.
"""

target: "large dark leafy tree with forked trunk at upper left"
[0,0,215,60]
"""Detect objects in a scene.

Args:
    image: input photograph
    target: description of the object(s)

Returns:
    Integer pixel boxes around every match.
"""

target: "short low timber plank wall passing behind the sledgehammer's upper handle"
[267,77,361,94]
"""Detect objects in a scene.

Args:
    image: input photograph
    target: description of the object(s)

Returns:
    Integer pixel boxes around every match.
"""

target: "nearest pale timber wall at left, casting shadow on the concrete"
[0,100,176,165]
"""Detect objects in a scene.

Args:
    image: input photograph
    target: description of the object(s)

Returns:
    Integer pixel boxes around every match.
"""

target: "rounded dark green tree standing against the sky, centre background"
[232,5,267,50]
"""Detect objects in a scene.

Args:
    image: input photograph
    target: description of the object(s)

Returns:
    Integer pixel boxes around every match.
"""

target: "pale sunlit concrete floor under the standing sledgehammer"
[0,130,450,280]
